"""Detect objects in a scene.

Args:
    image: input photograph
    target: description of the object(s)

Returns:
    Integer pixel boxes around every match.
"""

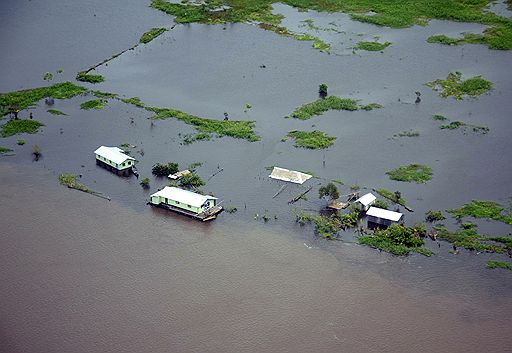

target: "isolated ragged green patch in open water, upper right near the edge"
[427,72,492,99]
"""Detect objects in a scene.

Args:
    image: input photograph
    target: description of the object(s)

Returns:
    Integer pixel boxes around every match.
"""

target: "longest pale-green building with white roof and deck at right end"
[149,186,223,221]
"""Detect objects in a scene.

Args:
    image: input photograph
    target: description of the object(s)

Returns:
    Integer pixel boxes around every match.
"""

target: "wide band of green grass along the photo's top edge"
[151,0,512,49]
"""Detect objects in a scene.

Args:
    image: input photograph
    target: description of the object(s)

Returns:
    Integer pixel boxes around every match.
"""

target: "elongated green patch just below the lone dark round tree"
[291,96,380,120]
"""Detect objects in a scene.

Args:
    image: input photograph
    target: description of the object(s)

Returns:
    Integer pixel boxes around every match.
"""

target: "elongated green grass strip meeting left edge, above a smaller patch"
[0,82,87,115]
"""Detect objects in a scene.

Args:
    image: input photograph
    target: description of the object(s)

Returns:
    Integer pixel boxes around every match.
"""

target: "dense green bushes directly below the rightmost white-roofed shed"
[358,224,432,256]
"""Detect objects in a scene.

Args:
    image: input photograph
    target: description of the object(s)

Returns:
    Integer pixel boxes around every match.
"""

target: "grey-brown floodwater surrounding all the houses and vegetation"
[0,0,512,352]
